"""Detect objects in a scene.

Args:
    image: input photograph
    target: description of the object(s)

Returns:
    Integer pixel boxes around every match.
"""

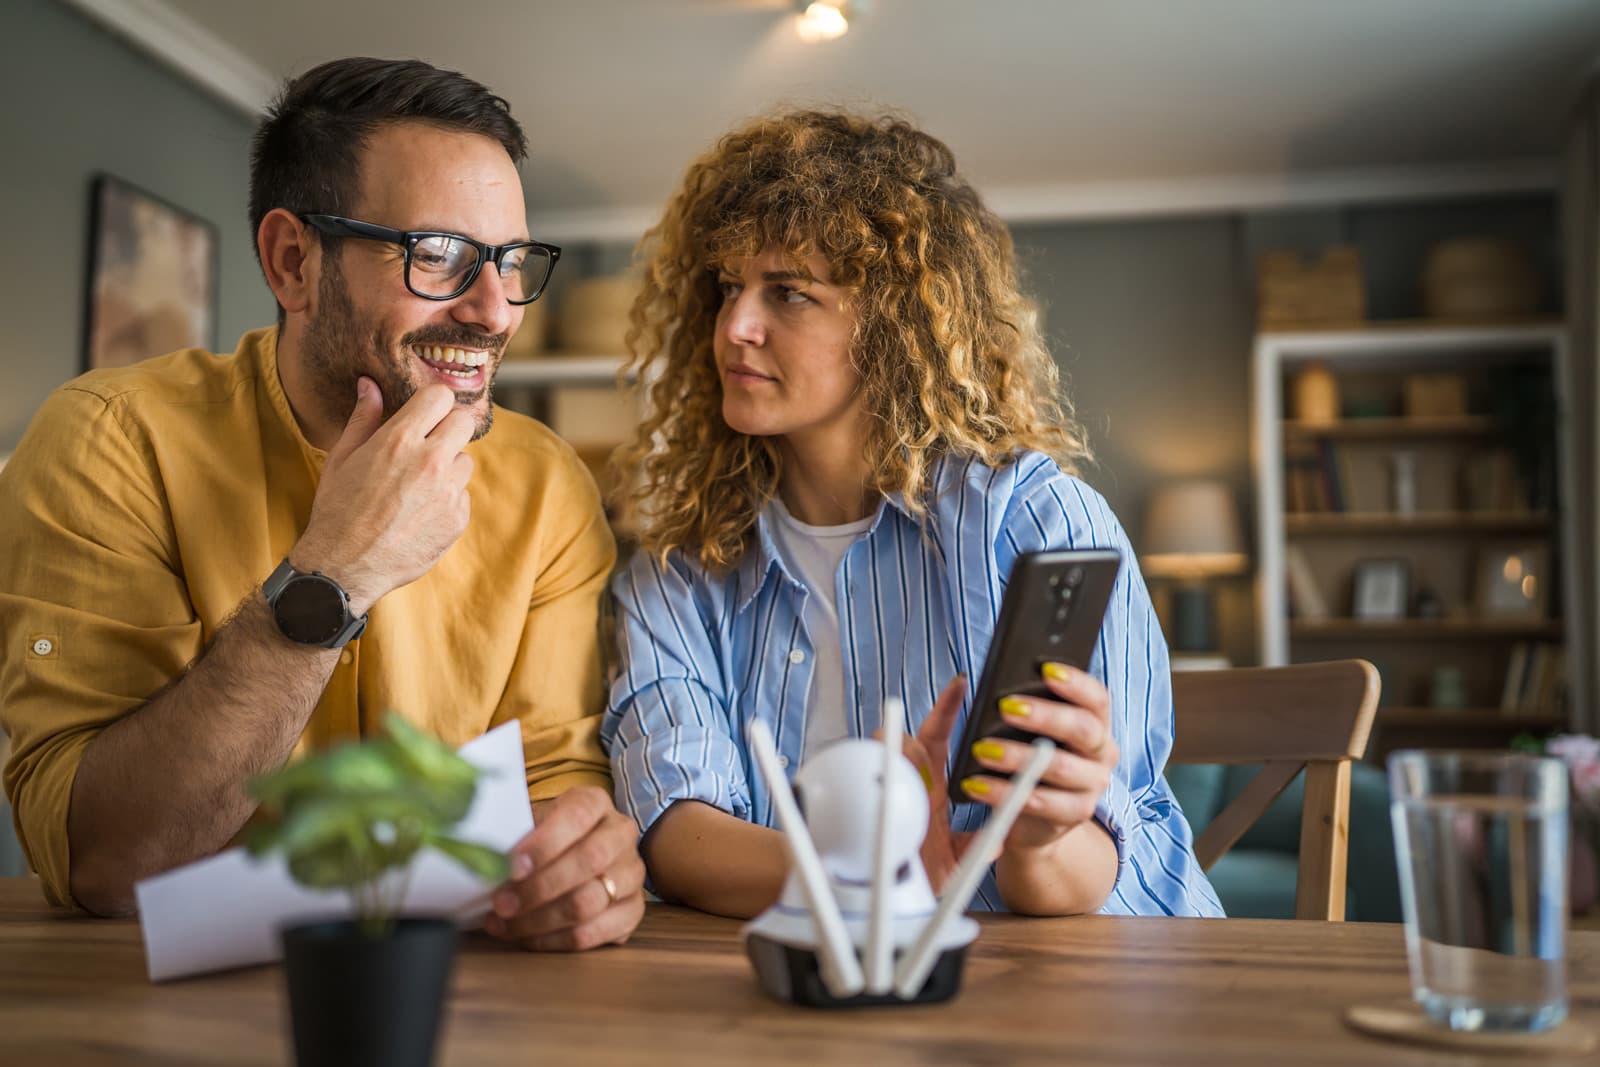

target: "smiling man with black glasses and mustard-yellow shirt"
[0,59,643,949]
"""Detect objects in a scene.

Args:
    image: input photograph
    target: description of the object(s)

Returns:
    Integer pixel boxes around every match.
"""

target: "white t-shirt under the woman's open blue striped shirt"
[771,498,874,758]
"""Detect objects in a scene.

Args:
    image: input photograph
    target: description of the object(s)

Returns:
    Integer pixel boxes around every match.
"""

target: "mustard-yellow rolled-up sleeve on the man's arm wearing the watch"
[0,387,203,904]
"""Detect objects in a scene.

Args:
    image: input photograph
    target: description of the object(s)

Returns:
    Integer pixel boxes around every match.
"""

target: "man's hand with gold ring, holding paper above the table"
[485,785,645,952]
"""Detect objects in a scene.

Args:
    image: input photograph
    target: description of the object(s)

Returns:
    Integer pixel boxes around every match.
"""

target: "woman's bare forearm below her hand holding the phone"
[995,819,1117,915]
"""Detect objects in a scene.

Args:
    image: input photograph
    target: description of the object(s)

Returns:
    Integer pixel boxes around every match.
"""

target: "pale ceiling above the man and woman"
[72,0,1600,238]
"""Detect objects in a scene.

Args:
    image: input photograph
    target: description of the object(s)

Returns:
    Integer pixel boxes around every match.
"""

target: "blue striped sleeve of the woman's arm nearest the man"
[602,552,752,833]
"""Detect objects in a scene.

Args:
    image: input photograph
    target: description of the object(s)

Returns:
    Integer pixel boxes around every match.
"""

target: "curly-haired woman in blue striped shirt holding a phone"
[603,110,1221,915]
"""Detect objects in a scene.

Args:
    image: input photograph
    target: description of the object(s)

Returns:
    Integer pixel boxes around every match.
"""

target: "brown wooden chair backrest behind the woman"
[1171,659,1379,920]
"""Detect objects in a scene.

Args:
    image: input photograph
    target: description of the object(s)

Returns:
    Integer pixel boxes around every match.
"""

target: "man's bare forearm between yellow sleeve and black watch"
[67,590,339,915]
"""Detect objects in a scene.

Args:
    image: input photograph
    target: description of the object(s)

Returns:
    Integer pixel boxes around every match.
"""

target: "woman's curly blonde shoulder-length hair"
[616,110,1088,569]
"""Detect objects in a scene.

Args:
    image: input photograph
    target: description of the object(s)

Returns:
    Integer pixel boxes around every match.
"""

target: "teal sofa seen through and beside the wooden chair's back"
[1166,761,1400,923]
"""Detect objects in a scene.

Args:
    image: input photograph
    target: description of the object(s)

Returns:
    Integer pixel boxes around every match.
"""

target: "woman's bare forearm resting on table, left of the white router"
[642,800,789,918]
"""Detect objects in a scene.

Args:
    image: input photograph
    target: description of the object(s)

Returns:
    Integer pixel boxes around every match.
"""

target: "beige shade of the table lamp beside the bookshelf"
[1139,482,1250,577]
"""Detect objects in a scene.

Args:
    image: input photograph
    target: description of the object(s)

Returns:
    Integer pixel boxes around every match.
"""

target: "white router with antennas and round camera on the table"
[744,697,1054,1008]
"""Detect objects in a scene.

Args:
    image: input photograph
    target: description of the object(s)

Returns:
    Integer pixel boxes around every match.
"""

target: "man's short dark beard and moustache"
[304,256,507,440]
